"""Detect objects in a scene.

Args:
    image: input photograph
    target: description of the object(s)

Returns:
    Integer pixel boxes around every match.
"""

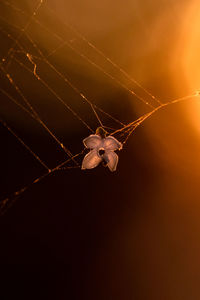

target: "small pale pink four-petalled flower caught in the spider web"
[82,134,122,172]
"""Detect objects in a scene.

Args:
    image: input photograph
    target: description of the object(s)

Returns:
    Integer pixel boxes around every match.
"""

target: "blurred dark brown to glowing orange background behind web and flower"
[0,0,200,300]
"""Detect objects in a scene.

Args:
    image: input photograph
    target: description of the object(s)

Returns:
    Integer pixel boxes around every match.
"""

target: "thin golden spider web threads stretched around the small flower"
[0,0,200,217]
